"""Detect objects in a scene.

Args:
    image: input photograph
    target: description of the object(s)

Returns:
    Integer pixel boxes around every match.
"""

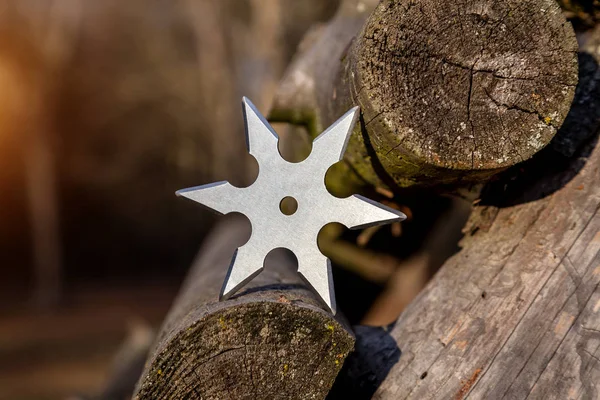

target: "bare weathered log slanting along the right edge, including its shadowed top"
[342,26,600,399]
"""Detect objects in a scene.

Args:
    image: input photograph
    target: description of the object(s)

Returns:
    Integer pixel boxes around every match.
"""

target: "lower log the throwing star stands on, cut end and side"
[134,216,354,399]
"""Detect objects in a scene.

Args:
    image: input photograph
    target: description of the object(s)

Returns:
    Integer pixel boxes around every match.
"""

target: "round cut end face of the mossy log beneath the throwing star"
[135,299,354,399]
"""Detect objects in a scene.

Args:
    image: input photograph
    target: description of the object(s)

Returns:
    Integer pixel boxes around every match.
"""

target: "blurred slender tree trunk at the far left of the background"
[32,0,81,305]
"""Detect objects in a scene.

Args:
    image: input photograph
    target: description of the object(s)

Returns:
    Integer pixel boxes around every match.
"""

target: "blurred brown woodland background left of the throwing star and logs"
[0,0,337,400]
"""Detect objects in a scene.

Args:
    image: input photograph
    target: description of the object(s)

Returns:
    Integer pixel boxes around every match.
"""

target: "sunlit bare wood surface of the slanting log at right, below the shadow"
[377,138,600,399]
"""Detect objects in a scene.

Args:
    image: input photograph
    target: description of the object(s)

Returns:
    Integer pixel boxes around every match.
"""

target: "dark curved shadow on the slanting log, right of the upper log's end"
[480,52,600,208]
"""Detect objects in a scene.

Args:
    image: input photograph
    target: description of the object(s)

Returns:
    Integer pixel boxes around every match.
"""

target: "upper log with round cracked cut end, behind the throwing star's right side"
[271,0,577,188]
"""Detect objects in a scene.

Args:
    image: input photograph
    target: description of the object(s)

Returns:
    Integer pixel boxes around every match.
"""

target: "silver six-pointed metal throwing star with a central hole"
[177,97,406,314]
